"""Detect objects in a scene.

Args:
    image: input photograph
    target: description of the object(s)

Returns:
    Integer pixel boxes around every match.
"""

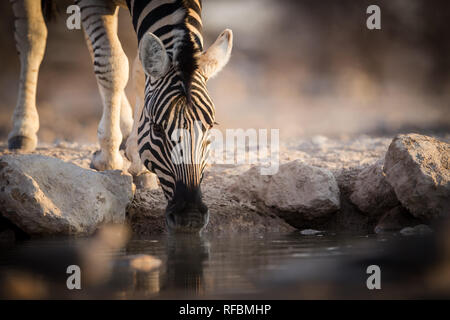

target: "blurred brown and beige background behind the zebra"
[0,0,450,143]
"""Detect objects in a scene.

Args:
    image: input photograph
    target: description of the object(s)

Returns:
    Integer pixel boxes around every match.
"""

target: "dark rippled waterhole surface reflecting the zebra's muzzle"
[0,232,432,299]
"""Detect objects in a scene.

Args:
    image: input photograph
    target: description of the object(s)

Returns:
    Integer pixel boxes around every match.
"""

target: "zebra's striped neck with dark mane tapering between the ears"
[127,0,203,101]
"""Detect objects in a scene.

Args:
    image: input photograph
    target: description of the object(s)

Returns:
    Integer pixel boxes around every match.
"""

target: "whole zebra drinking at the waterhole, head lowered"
[8,0,233,233]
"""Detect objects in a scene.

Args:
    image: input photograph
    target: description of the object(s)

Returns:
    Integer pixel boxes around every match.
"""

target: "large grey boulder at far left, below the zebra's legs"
[0,154,133,235]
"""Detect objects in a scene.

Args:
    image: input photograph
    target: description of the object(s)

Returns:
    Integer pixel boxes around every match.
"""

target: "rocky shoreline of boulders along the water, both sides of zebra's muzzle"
[0,134,450,238]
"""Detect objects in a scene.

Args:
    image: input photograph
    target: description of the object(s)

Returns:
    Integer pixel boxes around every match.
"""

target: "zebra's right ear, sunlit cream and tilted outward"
[198,29,233,79]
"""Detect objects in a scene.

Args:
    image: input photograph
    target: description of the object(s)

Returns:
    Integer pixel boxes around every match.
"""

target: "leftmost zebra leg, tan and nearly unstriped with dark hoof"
[8,0,47,151]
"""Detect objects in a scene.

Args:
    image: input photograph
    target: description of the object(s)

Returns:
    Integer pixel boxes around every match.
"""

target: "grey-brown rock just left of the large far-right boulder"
[350,159,400,216]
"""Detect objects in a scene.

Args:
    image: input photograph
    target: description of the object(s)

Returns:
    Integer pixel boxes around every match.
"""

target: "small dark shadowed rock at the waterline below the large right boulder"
[375,206,420,233]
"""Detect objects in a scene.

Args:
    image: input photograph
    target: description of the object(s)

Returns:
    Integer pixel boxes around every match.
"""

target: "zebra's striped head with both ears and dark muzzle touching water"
[138,30,233,232]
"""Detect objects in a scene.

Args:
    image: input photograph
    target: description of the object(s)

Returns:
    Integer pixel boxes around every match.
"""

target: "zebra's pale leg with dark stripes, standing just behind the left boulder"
[78,0,126,170]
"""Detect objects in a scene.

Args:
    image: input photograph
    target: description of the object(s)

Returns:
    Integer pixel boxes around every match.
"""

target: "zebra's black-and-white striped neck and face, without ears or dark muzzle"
[127,0,230,200]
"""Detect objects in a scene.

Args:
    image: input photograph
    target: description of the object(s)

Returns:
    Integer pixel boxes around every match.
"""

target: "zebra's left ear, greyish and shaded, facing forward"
[139,32,170,79]
